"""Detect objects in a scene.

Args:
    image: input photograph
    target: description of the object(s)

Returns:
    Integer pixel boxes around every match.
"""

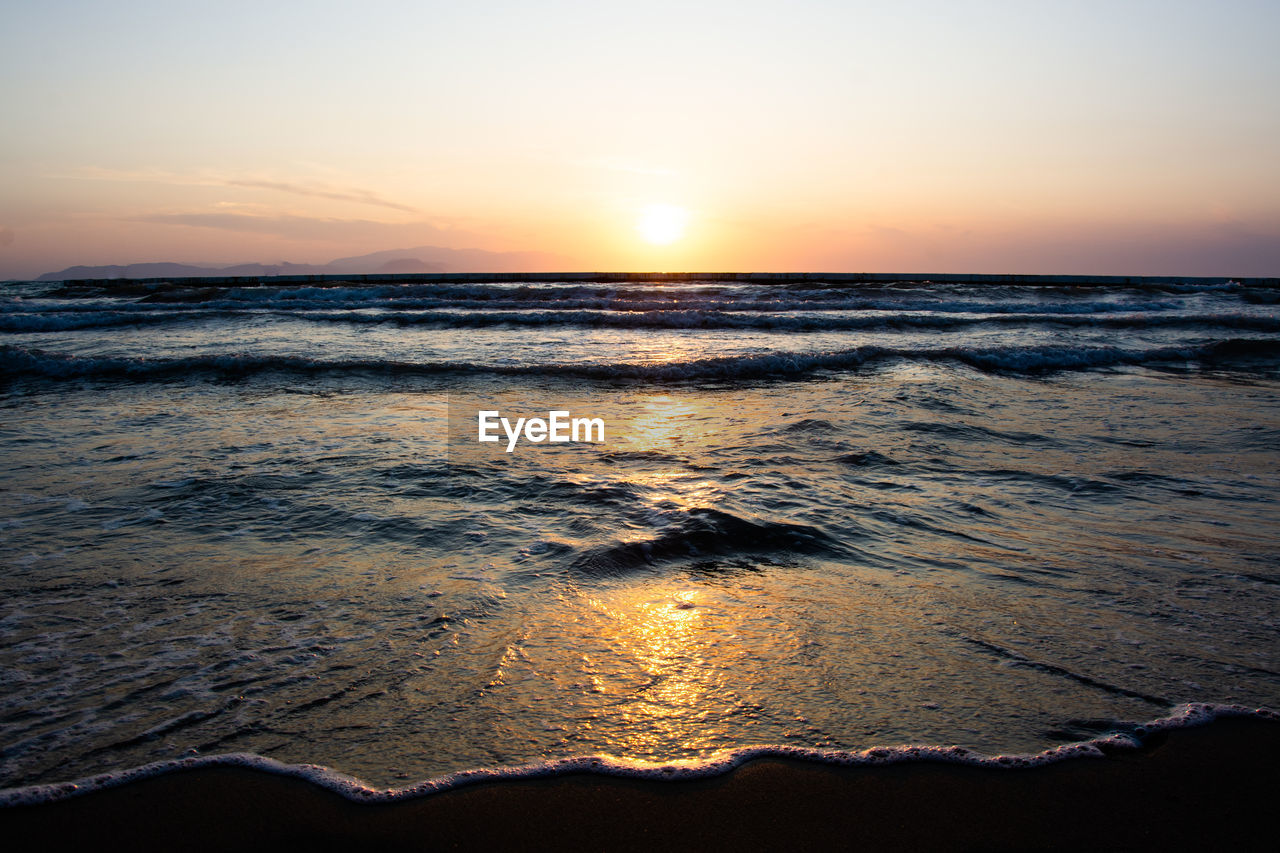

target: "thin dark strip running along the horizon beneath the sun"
[35,272,1280,288]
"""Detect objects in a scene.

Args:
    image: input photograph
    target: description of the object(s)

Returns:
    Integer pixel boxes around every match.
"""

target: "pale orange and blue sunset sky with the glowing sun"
[0,0,1280,278]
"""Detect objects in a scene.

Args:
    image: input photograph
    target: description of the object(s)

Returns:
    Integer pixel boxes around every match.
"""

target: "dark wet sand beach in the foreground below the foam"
[0,719,1280,850]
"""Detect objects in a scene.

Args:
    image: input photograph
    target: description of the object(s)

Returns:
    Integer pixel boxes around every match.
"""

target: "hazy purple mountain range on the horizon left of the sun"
[36,246,562,282]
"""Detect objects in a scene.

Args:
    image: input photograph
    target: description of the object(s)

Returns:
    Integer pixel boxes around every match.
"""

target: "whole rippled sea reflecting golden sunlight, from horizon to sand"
[0,280,1280,789]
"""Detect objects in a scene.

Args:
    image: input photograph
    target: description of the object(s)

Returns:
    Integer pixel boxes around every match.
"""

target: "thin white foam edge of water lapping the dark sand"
[0,703,1280,807]
